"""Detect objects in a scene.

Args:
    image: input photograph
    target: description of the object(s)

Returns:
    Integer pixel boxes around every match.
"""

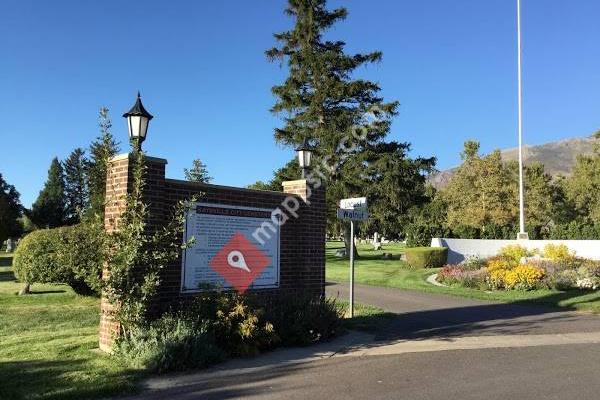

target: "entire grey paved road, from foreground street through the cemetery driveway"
[123,285,600,400]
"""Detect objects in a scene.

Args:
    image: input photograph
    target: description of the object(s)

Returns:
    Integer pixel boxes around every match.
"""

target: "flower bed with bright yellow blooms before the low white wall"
[437,244,600,290]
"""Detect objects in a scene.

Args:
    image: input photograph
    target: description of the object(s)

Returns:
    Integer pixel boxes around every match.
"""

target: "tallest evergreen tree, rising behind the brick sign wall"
[266,0,398,247]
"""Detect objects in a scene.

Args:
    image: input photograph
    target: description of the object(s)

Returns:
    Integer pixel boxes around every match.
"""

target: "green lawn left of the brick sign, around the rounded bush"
[0,255,139,400]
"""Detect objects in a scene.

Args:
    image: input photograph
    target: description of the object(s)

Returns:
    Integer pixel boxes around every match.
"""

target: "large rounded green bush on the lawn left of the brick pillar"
[13,224,104,295]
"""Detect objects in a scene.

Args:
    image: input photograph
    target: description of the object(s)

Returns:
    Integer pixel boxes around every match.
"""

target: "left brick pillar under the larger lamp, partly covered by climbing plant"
[99,154,167,352]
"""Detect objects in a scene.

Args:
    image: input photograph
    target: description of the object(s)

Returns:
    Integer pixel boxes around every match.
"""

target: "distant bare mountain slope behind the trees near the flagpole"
[429,137,595,189]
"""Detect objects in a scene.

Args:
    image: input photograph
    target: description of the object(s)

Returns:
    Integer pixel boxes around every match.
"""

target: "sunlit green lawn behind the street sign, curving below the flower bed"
[326,242,600,313]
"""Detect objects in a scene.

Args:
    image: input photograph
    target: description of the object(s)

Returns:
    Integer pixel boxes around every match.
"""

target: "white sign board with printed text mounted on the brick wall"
[181,203,280,292]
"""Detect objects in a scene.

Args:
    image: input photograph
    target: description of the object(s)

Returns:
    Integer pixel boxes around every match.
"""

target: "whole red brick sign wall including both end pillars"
[100,156,326,350]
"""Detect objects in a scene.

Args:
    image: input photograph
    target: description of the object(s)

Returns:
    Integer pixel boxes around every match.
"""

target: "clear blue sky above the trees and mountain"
[0,0,600,206]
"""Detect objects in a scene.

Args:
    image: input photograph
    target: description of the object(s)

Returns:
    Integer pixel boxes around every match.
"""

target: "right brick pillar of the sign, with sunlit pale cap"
[282,179,327,296]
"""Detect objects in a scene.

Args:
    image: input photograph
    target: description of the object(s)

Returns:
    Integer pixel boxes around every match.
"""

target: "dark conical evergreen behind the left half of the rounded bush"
[31,158,67,228]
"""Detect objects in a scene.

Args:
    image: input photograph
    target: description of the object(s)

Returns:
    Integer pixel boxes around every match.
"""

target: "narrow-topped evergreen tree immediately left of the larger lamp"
[87,107,119,219]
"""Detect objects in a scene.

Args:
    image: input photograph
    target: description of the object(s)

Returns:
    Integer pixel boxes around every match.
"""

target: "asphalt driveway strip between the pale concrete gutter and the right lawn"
[327,284,600,340]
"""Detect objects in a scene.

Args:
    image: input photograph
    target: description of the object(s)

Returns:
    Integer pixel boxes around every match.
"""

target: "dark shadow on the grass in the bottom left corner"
[0,359,140,400]
